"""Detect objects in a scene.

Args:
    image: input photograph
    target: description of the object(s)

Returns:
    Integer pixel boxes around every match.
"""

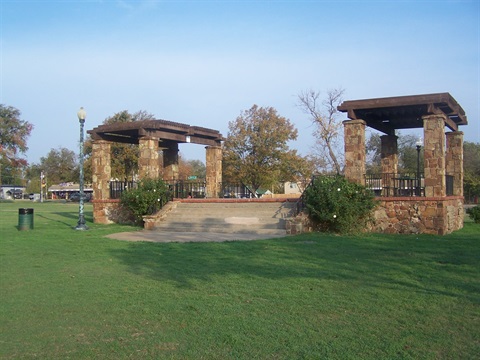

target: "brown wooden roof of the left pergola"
[87,120,223,146]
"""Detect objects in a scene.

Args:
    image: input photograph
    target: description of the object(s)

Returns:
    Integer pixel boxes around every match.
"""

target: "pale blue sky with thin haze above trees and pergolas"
[0,0,480,164]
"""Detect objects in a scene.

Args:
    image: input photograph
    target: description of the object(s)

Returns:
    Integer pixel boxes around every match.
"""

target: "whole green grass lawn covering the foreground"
[0,202,480,359]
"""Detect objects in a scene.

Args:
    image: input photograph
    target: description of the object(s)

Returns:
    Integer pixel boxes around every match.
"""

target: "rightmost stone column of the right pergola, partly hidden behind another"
[445,131,463,196]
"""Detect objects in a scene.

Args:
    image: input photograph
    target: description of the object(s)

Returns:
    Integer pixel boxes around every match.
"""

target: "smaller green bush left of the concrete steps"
[120,178,170,225]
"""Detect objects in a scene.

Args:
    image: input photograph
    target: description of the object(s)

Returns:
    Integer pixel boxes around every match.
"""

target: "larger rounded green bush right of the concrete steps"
[304,176,377,233]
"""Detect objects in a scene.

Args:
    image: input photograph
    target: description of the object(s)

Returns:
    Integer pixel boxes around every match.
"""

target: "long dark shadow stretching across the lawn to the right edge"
[109,226,480,303]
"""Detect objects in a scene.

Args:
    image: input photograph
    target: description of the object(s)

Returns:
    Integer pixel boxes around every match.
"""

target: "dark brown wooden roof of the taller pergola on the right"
[337,93,468,135]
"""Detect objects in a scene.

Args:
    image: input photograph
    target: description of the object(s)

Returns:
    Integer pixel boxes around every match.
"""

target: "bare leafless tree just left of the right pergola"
[297,89,345,174]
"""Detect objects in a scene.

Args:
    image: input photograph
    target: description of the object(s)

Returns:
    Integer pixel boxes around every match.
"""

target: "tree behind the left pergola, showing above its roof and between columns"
[85,110,155,180]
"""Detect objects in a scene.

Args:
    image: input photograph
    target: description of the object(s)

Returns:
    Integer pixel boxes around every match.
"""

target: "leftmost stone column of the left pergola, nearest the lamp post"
[92,140,112,200]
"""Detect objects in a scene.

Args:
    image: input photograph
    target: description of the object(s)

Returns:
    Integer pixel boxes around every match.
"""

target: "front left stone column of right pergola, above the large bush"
[343,120,366,185]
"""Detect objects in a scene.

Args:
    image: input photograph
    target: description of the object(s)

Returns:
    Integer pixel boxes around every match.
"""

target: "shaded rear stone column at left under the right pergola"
[380,135,398,196]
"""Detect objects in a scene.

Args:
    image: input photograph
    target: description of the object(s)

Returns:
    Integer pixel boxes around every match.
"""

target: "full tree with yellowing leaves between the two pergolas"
[223,105,306,193]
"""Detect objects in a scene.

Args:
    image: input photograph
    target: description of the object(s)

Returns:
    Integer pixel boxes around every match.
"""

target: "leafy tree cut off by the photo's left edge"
[0,104,33,184]
